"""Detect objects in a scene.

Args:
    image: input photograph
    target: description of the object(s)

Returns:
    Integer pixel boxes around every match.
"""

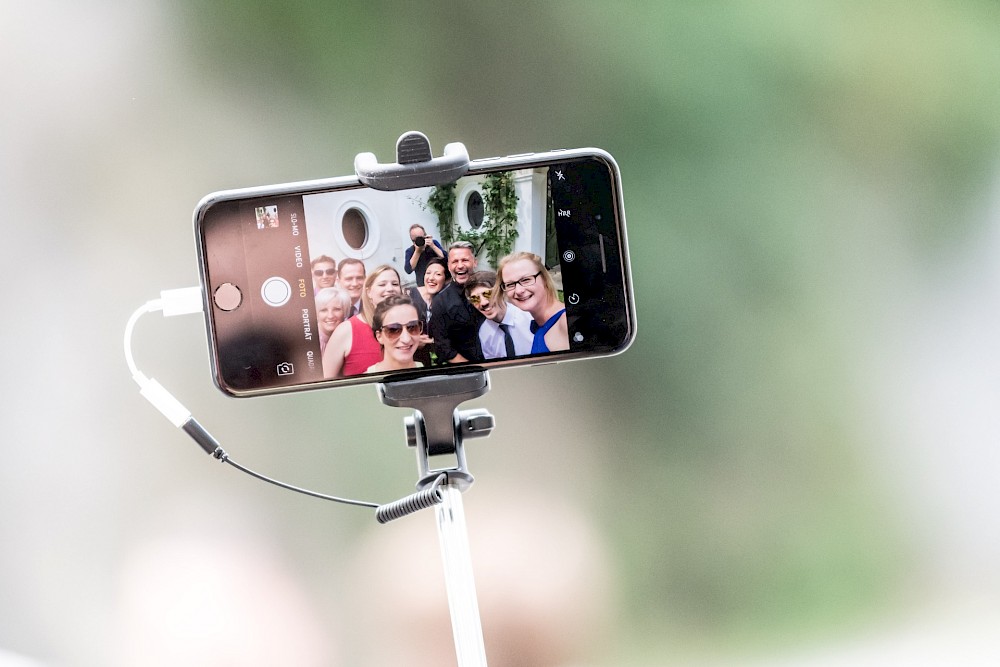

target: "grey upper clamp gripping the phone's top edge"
[354,132,469,190]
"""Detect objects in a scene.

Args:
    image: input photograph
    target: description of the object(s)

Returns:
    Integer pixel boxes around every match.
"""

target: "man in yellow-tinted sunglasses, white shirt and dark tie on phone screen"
[465,271,535,359]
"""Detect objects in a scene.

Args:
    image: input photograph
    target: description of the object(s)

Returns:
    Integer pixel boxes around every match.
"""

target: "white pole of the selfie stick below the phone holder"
[435,484,486,667]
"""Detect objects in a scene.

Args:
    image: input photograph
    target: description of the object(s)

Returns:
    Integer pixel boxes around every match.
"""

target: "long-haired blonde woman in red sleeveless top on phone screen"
[323,264,400,378]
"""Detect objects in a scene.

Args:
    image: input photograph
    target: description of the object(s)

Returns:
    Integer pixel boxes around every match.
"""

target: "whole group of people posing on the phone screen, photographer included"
[312,225,569,378]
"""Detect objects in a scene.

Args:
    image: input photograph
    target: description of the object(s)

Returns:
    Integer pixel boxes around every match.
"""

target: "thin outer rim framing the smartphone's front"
[194,148,636,398]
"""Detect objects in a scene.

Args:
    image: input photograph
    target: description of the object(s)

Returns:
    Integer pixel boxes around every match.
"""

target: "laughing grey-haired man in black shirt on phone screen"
[430,241,484,364]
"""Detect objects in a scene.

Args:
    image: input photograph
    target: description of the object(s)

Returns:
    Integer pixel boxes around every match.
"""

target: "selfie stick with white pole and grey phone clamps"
[354,132,495,667]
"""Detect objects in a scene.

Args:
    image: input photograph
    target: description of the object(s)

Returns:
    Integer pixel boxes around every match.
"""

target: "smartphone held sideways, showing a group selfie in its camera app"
[194,149,635,396]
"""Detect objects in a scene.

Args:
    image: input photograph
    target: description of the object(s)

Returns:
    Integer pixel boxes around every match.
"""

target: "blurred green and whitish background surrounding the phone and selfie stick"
[0,0,1000,667]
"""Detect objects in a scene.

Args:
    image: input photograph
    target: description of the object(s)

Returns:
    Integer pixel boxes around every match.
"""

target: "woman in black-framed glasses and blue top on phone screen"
[497,252,569,354]
